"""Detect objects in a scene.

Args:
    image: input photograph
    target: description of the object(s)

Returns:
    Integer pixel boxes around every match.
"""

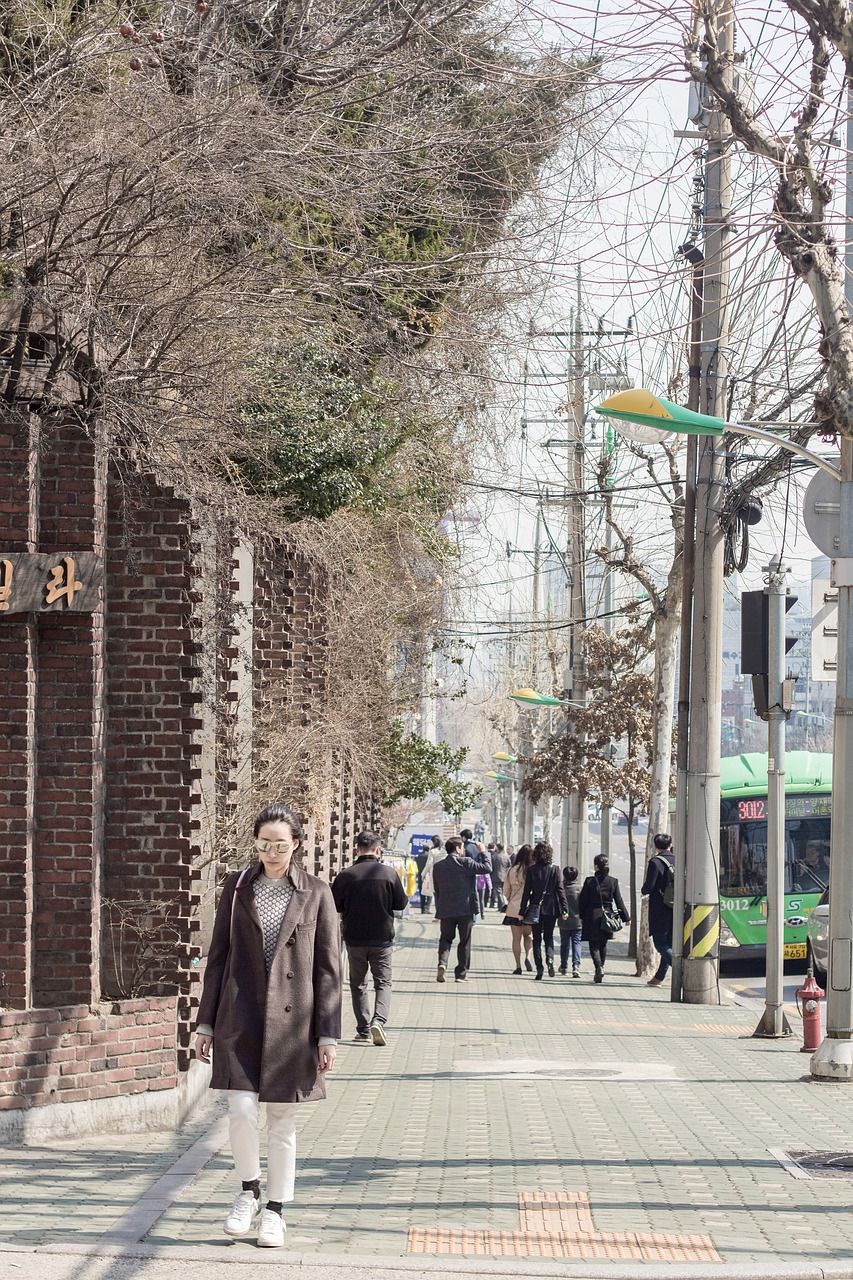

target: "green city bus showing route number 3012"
[720,751,833,961]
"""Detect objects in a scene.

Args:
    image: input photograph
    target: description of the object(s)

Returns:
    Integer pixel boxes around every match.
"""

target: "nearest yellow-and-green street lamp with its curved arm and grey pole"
[596,388,853,1082]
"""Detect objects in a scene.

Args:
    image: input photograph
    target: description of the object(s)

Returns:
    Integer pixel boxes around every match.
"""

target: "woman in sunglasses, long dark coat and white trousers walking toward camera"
[196,804,341,1248]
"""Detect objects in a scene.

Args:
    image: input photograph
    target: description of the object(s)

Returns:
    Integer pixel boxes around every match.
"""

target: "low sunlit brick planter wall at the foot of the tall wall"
[0,996,178,1111]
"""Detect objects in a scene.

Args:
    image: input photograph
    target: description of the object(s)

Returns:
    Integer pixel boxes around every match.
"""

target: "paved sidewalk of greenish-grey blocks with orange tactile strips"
[0,913,853,1277]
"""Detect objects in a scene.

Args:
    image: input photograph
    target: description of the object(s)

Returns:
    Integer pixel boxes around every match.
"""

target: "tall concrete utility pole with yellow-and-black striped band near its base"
[676,0,734,1005]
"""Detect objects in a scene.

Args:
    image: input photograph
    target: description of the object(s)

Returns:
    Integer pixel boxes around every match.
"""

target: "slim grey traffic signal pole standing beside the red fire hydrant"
[754,556,790,1038]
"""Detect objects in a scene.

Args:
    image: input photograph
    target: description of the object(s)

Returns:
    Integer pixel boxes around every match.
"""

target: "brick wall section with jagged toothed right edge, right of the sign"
[101,472,201,1066]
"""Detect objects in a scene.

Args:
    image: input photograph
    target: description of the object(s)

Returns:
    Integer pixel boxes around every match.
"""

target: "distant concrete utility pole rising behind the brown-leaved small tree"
[562,266,588,874]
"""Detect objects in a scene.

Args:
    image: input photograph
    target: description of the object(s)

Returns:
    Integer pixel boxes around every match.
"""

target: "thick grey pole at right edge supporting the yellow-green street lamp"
[811,67,853,1080]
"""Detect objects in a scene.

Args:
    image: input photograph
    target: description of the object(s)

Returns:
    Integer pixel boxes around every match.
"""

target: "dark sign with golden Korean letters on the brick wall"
[0,548,104,620]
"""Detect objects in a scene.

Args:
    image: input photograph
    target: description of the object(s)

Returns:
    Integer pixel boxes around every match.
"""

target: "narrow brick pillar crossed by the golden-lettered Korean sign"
[32,422,106,1007]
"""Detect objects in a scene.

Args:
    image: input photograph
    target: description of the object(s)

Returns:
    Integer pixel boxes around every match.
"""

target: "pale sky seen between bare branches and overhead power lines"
[438,0,841,757]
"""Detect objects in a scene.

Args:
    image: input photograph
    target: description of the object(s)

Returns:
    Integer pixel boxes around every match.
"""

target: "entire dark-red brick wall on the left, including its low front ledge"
[0,401,379,1111]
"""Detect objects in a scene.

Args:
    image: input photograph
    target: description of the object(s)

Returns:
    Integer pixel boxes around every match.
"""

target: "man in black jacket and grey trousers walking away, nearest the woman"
[332,831,409,1046]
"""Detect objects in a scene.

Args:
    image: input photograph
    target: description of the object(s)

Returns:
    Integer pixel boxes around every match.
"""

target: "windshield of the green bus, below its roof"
[720,795,831,897]
